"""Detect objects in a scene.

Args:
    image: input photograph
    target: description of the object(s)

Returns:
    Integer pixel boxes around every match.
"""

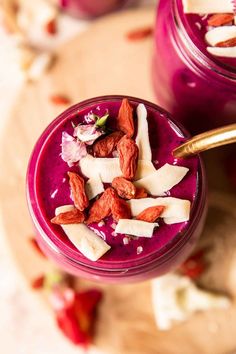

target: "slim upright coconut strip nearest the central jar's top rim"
[136,103,152,161]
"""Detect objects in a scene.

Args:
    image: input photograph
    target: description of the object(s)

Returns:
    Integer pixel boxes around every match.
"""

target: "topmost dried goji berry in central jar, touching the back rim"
[117,98,134,138]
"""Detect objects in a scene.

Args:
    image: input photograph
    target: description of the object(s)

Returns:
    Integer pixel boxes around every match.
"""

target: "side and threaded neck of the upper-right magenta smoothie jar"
[152,0,236,133]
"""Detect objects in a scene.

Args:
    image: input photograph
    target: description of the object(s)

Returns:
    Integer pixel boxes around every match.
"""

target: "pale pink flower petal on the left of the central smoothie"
[61,131,87,167]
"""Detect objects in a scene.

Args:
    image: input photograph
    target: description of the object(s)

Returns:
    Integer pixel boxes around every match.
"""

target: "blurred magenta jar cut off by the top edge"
[59,0,127,19]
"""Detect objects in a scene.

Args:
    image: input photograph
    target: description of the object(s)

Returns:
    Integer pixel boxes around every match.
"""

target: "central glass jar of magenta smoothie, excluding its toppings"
[27,96,205,280]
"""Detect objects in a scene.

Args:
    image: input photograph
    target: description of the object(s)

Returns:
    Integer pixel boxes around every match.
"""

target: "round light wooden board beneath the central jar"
[0,9,236,354]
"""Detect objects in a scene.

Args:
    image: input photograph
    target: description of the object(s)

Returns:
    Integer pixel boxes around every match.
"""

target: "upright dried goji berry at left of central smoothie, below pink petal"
[68,172,89,211]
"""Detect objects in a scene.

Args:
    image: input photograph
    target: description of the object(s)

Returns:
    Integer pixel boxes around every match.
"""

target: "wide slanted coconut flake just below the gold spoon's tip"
[135,163,189,196]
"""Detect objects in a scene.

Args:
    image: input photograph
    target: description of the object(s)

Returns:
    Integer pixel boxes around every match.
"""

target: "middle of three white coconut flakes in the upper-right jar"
[205,26,236,47]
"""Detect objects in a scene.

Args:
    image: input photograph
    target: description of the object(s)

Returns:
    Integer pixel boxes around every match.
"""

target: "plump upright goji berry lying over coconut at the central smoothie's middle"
[117,135,139,179]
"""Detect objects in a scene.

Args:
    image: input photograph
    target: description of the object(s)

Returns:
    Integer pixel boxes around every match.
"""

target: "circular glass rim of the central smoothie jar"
[26,95,205,275]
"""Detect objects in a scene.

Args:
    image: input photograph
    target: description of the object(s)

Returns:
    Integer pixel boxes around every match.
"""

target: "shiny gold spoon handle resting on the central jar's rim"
[173,124,236,157]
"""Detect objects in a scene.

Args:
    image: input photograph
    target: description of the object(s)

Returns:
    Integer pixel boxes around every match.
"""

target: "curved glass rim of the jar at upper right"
[171,0,236,81]
